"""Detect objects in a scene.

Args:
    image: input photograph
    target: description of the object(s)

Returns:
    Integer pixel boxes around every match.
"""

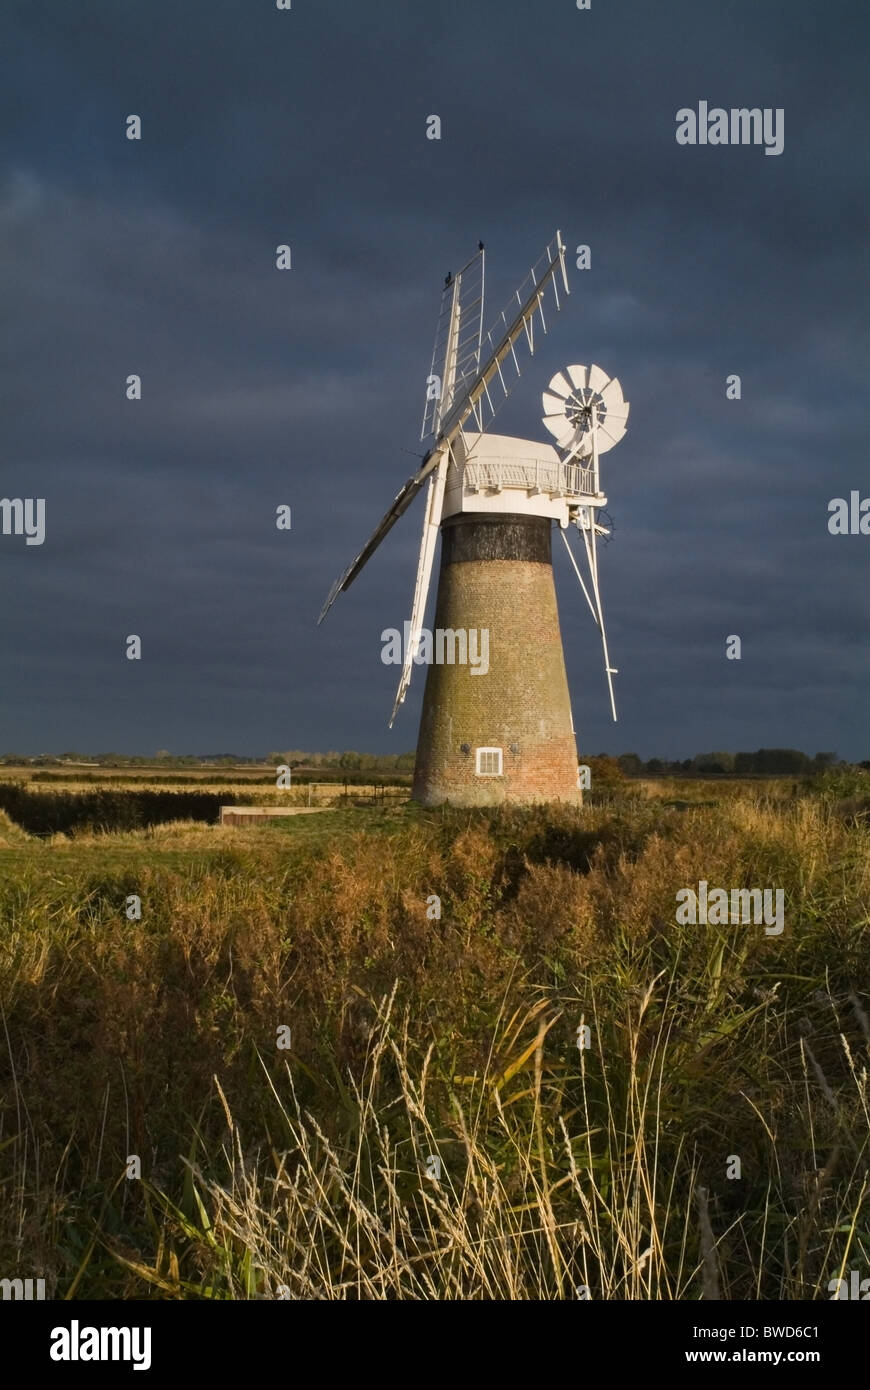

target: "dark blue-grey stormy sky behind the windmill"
[0,0,870,759]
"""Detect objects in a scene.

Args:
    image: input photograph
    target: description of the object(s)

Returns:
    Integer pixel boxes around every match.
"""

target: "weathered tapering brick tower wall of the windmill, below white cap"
[413,514,582,805]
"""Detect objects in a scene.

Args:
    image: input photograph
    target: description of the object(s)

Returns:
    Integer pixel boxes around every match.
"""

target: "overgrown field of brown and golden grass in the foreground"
[0,774,870,1300]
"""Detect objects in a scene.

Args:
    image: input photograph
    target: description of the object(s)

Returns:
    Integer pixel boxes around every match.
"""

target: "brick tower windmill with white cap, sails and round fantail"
[318,232,628,805]
